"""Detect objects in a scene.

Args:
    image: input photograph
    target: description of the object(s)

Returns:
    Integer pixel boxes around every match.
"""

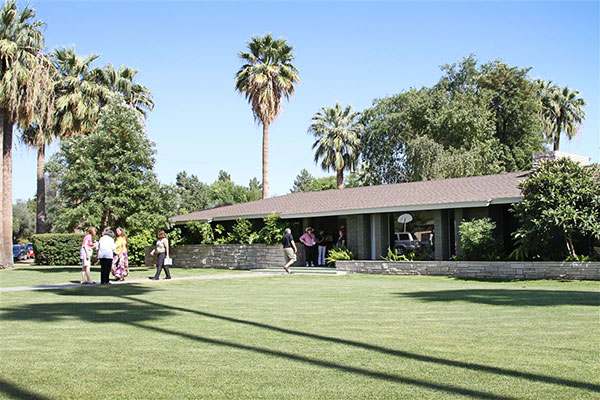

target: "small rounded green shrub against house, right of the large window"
[458,218,501,261]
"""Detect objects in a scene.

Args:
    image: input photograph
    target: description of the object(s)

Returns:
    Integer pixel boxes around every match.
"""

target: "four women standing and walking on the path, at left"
[79,227,171,285]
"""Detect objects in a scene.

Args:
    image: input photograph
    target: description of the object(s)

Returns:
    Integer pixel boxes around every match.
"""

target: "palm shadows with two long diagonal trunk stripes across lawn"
[0,285,600,399]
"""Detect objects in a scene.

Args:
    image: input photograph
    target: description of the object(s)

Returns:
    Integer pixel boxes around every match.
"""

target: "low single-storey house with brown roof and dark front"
[171,172,528,260]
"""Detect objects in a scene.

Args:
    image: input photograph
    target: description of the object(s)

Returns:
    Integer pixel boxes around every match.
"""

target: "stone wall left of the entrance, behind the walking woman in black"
[145,243,304,270]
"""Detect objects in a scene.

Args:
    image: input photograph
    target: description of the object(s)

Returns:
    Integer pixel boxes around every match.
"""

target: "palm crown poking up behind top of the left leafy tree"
[92,64,154,120]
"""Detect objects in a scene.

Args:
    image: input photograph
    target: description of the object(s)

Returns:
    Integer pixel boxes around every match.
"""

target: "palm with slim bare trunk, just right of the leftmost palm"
[22,48,106,233]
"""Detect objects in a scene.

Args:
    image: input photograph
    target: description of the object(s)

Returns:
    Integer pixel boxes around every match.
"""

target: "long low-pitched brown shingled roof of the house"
[171,172,529,223]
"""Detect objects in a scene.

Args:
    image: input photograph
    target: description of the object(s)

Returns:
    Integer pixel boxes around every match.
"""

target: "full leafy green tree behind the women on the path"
[47,97,175,234]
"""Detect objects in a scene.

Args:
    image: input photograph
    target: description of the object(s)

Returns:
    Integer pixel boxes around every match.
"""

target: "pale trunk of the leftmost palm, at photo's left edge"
[0,110,13,268]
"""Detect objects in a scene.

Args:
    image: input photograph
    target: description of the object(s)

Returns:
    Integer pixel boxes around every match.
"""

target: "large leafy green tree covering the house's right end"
[513,158,600,258]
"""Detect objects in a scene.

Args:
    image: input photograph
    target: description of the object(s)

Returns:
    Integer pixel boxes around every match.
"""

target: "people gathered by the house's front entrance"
[282,226,347,274]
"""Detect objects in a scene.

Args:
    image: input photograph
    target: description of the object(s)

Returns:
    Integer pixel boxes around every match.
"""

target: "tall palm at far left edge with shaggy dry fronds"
[0,0,53,268]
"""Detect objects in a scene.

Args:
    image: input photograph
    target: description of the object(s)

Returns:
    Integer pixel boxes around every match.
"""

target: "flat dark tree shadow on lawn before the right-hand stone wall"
[396,289,600,307]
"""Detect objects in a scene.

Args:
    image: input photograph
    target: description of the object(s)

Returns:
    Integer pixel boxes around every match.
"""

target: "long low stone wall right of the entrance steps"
[335,261,600,280]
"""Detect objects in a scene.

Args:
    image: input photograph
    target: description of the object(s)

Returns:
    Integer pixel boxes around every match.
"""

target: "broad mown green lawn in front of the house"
[0,271,600,400]
